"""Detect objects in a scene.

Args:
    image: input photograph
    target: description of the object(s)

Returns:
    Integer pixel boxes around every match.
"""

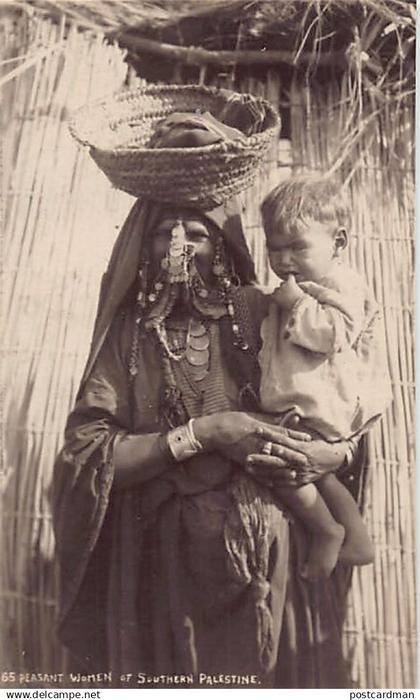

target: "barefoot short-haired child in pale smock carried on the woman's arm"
[259,177,390,578]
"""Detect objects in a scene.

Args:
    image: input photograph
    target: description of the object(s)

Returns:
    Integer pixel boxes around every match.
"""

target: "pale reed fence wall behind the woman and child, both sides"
[0,10,416,688]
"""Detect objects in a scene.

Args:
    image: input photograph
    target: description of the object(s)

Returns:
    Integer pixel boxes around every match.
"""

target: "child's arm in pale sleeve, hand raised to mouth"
[273,276,363,355]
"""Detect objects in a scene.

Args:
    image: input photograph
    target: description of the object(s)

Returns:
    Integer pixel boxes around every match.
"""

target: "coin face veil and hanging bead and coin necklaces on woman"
[128,227,251,400]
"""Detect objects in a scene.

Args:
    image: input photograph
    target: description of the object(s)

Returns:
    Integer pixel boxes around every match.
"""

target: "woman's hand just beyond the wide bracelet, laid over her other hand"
[194,411,311,481]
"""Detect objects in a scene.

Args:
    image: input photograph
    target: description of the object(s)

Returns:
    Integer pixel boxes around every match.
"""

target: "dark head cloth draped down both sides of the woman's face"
[79,199,256,391]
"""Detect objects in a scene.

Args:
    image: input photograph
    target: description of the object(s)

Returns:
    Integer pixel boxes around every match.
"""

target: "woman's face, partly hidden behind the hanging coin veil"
[150,210,217,283]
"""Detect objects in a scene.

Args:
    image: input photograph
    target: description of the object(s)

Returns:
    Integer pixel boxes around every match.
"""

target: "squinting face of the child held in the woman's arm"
[266,220,338,282]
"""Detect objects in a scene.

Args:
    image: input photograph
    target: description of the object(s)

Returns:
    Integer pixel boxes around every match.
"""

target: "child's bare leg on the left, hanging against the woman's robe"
[278,484,345,579]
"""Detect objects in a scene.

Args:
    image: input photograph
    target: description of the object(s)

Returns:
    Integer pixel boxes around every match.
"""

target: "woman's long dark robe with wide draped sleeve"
[54,288,364,688]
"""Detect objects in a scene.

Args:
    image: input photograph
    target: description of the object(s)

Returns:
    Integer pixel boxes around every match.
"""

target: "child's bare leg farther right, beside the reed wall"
[317,474,374,566]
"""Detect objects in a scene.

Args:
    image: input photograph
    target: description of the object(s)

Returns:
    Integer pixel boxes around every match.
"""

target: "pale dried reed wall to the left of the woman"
[0,12,136,672]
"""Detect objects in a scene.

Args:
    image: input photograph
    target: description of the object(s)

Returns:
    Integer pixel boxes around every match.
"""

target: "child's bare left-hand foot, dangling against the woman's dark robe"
[301,523,345,580]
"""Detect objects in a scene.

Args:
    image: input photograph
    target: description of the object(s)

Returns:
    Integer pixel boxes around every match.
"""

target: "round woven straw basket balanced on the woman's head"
[69,85,280,209]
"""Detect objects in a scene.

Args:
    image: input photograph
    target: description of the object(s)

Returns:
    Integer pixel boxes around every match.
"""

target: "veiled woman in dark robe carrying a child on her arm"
[54,104,364,687]
